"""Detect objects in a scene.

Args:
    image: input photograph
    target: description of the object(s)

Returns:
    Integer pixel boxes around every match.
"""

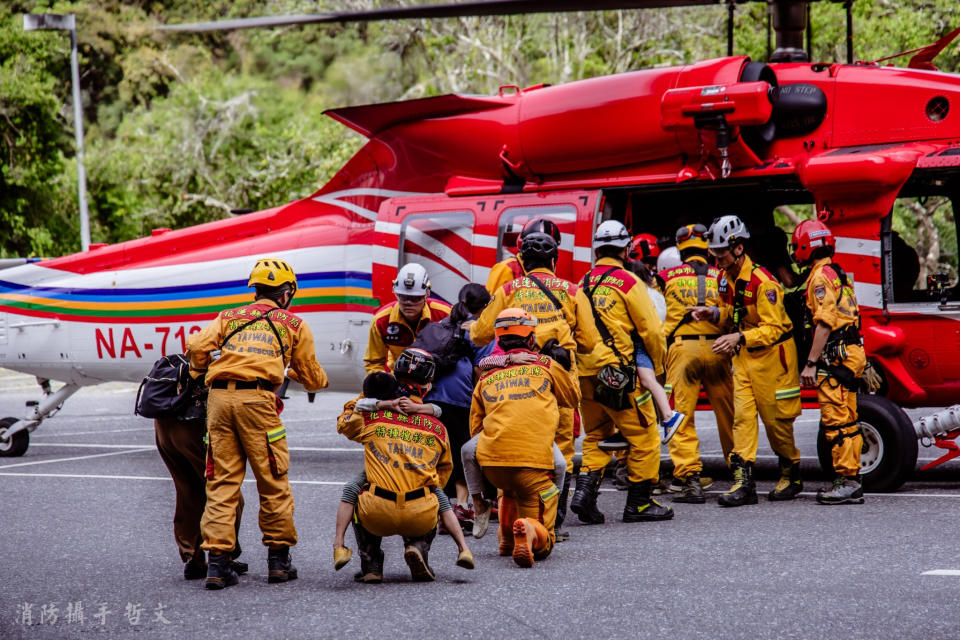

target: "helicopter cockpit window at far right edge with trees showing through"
[883,195,960,302]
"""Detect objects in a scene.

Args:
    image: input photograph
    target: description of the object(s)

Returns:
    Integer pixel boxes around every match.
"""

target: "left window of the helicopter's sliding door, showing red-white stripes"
[397,211,473,303]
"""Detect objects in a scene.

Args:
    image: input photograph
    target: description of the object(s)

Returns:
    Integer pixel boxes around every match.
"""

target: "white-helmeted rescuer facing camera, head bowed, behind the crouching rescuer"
[363,262,450,373]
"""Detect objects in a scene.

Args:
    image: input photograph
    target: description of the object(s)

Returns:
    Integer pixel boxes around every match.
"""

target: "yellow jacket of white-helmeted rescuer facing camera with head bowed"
[363,299,450,374]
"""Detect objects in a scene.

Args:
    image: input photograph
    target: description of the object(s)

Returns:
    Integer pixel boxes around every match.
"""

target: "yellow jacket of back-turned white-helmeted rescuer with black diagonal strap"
[577,258,667,376]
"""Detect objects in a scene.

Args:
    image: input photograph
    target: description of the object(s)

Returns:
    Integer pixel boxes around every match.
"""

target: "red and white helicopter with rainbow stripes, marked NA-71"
[0,0,960,490]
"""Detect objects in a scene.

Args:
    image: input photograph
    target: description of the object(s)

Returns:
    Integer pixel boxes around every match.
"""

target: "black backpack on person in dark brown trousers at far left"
[133,353,207,420]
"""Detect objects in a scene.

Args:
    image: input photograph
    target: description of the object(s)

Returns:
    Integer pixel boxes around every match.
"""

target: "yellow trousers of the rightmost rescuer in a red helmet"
[817,345,867,476]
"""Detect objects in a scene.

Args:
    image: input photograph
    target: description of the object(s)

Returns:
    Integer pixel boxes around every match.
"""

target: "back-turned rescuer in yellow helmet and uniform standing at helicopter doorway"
[660,224,733,504]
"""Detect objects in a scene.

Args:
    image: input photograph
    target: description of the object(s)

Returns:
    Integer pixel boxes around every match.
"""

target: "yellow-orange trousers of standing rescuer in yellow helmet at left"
[200,384,297,553]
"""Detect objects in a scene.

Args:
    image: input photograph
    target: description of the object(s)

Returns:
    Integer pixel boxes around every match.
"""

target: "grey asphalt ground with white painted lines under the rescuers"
[0,376,960,640]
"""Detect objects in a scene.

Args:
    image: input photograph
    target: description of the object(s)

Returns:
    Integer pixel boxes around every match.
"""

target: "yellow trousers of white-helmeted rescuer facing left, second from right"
[727,338,801,462]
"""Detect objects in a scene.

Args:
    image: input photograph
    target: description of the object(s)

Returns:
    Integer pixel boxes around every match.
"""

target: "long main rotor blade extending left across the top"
[156,0,728,33]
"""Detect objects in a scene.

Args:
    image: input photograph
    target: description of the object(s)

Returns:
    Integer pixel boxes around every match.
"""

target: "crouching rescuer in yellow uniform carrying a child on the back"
[337,349,453,582]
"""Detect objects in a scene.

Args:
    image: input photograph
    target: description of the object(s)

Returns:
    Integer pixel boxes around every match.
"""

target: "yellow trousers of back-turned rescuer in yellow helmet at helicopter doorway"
[664,336,733,478]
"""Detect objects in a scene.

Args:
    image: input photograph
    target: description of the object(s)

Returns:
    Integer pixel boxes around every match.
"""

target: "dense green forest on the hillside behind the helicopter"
[0,0,960,274]
